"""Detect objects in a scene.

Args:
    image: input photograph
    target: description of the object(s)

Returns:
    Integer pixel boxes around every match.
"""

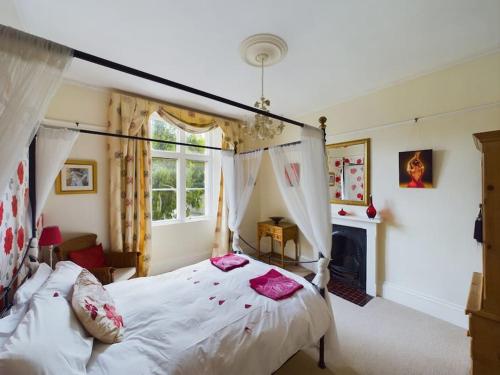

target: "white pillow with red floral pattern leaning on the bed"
[71,269,124,344]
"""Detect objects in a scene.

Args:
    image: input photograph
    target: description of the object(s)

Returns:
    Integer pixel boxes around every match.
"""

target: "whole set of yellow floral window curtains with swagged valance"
[108,93,243,270]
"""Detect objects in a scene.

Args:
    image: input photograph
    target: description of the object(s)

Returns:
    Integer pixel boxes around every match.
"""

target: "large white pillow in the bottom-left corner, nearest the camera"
[0,294,93,375]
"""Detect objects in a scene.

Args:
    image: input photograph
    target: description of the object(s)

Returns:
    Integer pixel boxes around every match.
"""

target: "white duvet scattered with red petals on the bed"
[87,260,331,375]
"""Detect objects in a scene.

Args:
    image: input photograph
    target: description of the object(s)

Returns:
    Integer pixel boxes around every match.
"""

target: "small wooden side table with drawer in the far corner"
[257,221,299,268]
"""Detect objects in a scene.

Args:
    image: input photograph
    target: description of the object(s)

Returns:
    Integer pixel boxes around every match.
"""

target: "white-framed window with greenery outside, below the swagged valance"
[150,114,213,222]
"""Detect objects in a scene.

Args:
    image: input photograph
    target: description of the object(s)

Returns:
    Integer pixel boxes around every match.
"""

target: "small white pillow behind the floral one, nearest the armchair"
[37,260,83,300]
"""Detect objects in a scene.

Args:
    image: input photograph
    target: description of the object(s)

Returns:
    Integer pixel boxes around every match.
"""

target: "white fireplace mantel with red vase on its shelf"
[332,214,381,296]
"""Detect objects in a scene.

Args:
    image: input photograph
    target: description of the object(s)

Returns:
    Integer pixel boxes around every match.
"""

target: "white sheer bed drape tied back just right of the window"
[222,150,263,252]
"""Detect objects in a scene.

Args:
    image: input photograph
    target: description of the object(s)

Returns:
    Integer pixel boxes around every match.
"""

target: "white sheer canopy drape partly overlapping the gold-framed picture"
[36,126,79,220]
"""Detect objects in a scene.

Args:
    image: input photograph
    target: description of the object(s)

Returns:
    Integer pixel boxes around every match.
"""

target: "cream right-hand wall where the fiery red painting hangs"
[245,53,500,326]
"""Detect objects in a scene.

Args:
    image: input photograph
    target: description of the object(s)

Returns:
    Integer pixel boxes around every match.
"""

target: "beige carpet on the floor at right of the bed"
[276,295,470,375]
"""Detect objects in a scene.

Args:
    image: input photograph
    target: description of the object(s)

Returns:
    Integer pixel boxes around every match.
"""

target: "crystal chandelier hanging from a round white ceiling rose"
[240,34,288,140]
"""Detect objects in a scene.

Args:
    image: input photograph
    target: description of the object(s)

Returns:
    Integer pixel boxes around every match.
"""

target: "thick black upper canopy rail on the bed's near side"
[71,48,306,128]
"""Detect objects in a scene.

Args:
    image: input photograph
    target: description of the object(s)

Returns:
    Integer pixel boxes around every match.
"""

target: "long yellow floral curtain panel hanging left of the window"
[108,93,151,276]
